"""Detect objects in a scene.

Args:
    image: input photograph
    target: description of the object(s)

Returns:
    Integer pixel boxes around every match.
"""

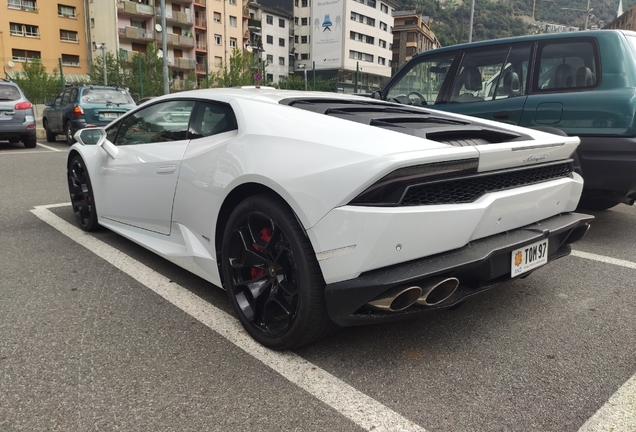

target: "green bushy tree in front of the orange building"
[14,58,62,103]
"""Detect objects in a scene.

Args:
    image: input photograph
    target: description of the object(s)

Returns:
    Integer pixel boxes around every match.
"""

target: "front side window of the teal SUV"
[386,53,456,105]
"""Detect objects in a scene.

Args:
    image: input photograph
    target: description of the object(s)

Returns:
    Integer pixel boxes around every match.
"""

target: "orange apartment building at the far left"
[0,0,89,82]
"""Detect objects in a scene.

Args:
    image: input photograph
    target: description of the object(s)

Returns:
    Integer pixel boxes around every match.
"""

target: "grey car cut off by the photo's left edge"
[0,80,37,148]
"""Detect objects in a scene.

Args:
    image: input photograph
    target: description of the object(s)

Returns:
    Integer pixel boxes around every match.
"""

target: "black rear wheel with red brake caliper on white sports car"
[221,195,334,350]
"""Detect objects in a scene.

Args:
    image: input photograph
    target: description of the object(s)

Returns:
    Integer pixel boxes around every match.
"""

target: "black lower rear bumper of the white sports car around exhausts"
[325,213,594,326]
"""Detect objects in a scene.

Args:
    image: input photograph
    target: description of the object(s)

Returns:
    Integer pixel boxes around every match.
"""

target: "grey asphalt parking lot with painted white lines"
[0,142,636,432]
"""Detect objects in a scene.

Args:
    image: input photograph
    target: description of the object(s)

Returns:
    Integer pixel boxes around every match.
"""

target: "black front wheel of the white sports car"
[67,155,99,231]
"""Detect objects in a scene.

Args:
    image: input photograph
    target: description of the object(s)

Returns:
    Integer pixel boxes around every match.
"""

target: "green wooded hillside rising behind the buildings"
[400,0,636,46]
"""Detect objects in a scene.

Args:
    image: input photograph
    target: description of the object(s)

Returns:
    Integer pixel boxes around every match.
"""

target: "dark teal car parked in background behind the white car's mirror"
[42,86,137,144]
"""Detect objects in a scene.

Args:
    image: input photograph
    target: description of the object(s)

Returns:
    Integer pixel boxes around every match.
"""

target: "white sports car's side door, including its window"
[94,100,194,235]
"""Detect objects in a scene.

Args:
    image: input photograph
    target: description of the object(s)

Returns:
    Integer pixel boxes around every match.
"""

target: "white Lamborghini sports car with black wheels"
[68,88,593,349]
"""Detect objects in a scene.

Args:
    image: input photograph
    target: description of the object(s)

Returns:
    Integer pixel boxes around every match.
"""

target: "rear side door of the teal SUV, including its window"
[434,43,532,125]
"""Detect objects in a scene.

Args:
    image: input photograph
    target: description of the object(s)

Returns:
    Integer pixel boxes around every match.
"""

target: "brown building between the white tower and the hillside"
[392,11,441,70]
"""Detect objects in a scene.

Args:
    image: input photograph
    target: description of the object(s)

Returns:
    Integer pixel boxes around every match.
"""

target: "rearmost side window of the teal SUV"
[534,41,599,92]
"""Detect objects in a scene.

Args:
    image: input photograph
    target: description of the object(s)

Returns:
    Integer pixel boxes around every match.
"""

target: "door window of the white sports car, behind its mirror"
[111,100,194,145]
